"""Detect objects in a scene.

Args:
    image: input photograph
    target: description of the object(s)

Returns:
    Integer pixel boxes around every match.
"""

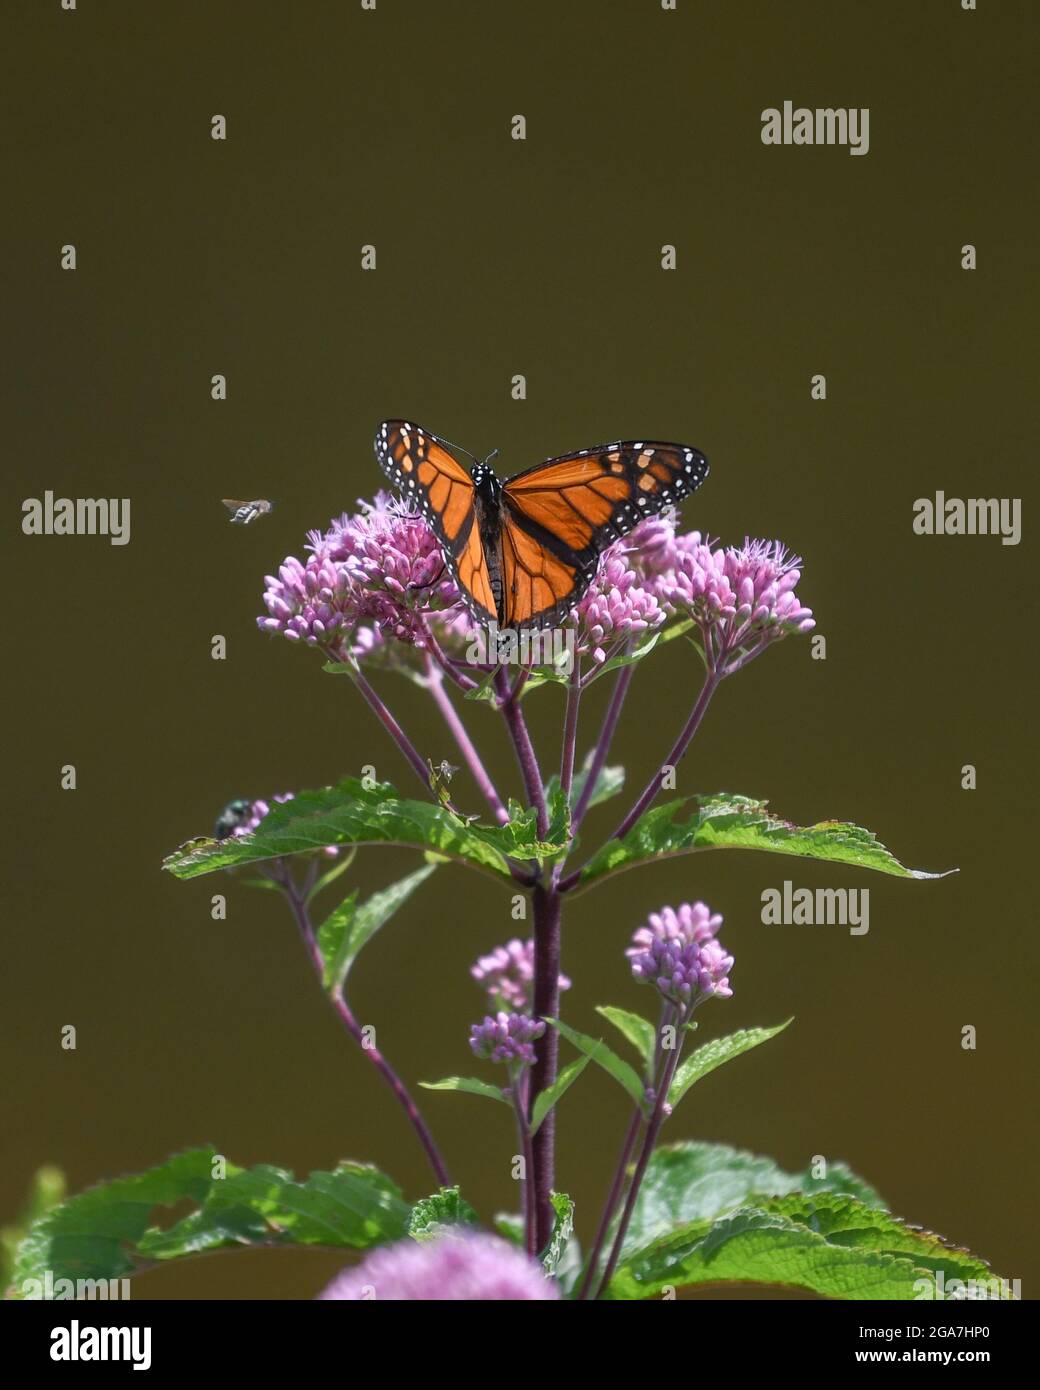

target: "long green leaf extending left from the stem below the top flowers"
[163,777,566,878]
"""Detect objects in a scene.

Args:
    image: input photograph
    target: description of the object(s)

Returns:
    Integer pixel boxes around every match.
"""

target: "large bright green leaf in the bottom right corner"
[609,1193,991,1300]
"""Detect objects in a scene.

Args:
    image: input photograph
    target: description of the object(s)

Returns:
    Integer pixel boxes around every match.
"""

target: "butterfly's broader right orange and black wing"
[502,441,708,627]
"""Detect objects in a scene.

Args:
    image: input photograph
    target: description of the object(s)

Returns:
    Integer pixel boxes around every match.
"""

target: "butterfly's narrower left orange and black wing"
[375,420,496,621]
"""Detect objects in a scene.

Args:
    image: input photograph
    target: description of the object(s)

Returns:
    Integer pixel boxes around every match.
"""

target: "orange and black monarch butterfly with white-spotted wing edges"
[375,420,708,628]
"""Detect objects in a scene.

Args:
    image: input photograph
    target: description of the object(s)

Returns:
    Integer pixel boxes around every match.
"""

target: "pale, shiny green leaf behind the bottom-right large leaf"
[621,1141,884,1258]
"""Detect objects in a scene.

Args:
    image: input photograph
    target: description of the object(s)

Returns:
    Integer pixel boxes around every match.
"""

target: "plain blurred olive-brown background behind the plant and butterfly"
[0,0,1040,1298]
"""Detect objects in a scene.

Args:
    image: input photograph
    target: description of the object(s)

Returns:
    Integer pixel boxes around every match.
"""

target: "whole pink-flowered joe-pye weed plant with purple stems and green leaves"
[4,480,1002,1300]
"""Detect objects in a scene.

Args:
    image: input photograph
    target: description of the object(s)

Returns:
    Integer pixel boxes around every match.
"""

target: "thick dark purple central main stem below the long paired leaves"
[531,884,562,1250]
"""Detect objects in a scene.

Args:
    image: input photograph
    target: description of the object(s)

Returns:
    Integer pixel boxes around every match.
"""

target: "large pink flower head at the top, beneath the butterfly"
[257,492,815,671]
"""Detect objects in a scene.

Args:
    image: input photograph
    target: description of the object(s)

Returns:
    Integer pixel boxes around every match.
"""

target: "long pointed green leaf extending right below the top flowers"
[576,792,957,891]
